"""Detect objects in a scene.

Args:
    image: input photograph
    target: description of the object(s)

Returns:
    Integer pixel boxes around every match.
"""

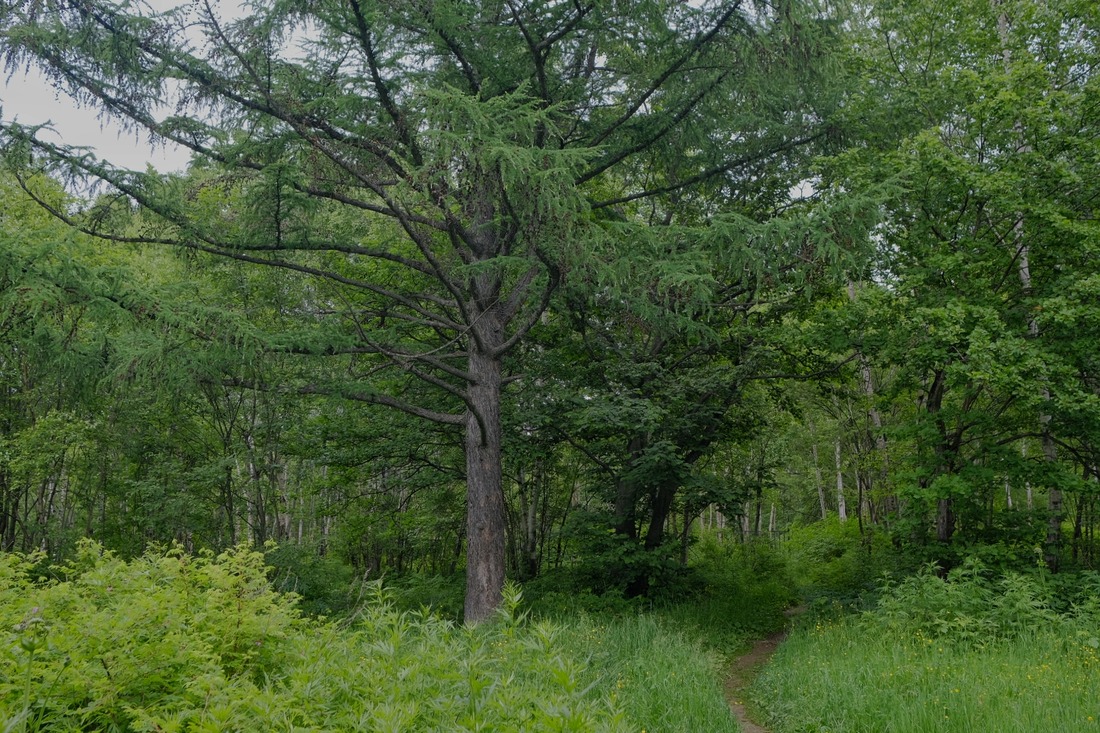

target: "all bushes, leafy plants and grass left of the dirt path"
[0,541,781,733]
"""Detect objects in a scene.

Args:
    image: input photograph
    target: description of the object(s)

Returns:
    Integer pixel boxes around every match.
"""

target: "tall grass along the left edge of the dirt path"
[536,530,794,733]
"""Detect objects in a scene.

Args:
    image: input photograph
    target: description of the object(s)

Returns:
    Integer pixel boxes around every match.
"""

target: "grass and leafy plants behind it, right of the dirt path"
[754,559,1100,733]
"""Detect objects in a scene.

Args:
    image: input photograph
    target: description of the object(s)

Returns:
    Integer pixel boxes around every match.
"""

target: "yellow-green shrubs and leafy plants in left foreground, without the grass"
[0,543,640,733]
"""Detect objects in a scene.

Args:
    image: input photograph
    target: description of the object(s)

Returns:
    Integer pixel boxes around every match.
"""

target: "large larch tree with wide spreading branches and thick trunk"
[0,0,840,622]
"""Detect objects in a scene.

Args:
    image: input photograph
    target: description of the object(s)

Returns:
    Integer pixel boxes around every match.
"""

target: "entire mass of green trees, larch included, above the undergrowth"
[0,0,1100,622]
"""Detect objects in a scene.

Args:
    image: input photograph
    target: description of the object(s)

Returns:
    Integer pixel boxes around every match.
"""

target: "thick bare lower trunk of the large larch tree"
[464,342,506,623]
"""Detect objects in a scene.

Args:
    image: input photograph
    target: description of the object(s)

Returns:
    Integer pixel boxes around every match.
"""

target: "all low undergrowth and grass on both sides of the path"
[21,523,1100,733]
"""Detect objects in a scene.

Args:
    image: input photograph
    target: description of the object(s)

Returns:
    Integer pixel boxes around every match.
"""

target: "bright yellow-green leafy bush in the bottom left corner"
[0,540,304,730]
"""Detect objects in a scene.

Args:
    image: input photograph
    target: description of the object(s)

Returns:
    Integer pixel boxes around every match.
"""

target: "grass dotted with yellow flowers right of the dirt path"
[752,621,1100,733]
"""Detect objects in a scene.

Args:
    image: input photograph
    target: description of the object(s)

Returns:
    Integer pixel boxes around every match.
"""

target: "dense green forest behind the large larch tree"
[0,0,1100,611]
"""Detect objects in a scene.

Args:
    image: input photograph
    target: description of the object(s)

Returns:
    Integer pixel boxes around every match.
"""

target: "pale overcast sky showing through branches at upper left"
[0,0,246,172]
